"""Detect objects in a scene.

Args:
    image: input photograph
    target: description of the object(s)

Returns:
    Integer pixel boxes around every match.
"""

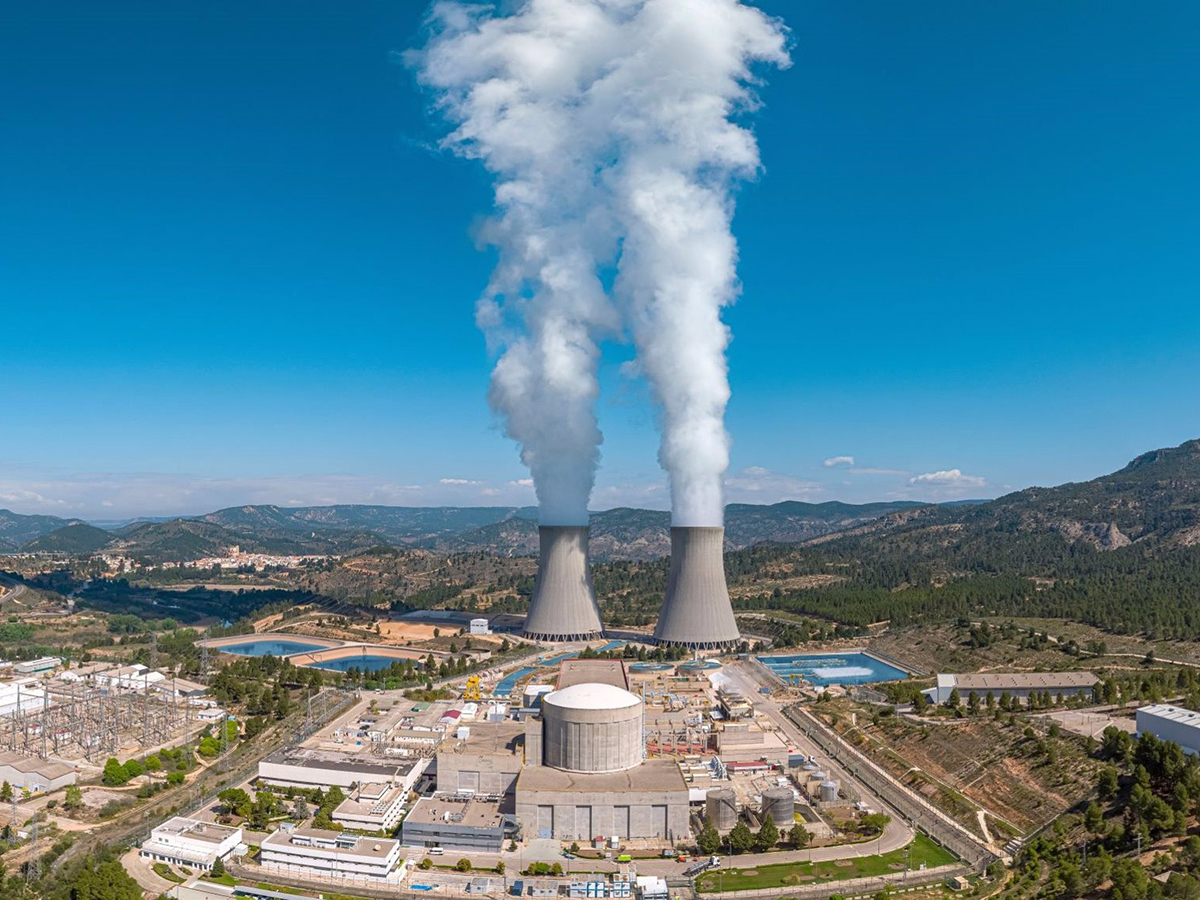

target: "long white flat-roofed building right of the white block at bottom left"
[259,823,400,882]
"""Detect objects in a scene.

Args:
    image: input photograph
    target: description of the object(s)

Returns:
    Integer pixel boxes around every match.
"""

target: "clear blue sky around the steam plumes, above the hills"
[0,0,1200,517]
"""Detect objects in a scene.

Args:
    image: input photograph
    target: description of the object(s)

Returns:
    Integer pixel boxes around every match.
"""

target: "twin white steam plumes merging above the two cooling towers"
[410,0,788,526]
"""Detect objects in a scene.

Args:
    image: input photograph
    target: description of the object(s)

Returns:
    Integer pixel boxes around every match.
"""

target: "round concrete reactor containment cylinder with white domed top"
[541,683,646,772]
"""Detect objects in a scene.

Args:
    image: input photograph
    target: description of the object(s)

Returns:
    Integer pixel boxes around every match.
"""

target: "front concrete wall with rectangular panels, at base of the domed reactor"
[517,791,690,841]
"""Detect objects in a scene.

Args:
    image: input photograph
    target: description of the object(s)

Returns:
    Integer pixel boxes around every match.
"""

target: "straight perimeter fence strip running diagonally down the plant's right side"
[784,706,997,871]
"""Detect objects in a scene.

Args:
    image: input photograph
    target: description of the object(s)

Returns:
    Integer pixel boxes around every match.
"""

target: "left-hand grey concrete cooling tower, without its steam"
[523,526,604,641]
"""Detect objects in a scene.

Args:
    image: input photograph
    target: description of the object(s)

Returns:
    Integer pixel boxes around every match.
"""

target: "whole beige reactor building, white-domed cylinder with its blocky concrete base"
[516,660,689,841]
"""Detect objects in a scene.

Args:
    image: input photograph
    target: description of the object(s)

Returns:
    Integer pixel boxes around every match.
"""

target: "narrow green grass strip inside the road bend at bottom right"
[696,834,958,894]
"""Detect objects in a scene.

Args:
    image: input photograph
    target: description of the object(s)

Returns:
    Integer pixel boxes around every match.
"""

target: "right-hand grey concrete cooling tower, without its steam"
[654,528,740,650]
